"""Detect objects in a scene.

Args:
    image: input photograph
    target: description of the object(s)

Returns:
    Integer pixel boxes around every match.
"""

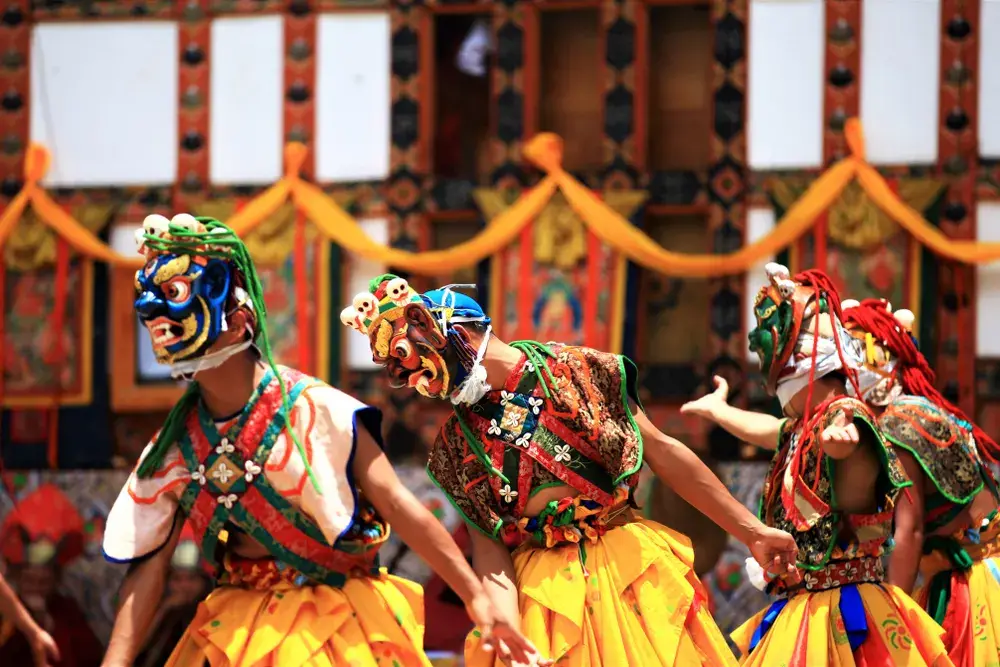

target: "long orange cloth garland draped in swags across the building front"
[0,118,1000,278]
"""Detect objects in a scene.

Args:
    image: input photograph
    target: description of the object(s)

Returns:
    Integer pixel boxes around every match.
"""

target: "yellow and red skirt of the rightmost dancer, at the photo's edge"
[913,558,1000,667]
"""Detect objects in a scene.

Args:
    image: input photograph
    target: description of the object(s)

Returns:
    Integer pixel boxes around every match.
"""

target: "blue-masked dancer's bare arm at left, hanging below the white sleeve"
[101,515,183,667]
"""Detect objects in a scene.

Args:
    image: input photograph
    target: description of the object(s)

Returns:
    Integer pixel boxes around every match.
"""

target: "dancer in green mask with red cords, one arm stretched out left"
[682,263,952,667]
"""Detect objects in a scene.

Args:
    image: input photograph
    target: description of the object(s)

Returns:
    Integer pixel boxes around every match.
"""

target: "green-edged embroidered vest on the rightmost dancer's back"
[878,396,988,531]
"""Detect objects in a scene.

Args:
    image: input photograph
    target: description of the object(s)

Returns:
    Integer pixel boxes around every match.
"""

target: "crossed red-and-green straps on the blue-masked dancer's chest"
[178,369,377,586]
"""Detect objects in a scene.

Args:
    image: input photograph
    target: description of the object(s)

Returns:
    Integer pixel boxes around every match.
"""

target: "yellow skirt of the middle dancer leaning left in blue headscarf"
[465,520,736,667]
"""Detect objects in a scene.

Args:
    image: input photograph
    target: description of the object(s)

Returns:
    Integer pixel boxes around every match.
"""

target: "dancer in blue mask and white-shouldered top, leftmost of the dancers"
[104,214,530,667]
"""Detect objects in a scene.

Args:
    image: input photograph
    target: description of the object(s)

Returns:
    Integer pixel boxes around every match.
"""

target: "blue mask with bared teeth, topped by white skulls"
[135,213,256,364]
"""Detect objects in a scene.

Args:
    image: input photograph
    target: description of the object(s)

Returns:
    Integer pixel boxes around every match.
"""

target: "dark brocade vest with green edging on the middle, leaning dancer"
[455,346,642,523]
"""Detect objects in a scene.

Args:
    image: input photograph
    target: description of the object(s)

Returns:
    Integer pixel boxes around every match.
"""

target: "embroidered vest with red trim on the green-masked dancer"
[759,397,910,571]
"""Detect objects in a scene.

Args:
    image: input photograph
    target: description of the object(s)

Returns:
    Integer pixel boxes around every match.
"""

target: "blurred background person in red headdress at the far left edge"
[0,484,104,667]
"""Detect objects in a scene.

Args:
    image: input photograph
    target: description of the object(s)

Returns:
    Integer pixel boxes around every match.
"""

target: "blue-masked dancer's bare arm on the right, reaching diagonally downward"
[354,428,537,661]
